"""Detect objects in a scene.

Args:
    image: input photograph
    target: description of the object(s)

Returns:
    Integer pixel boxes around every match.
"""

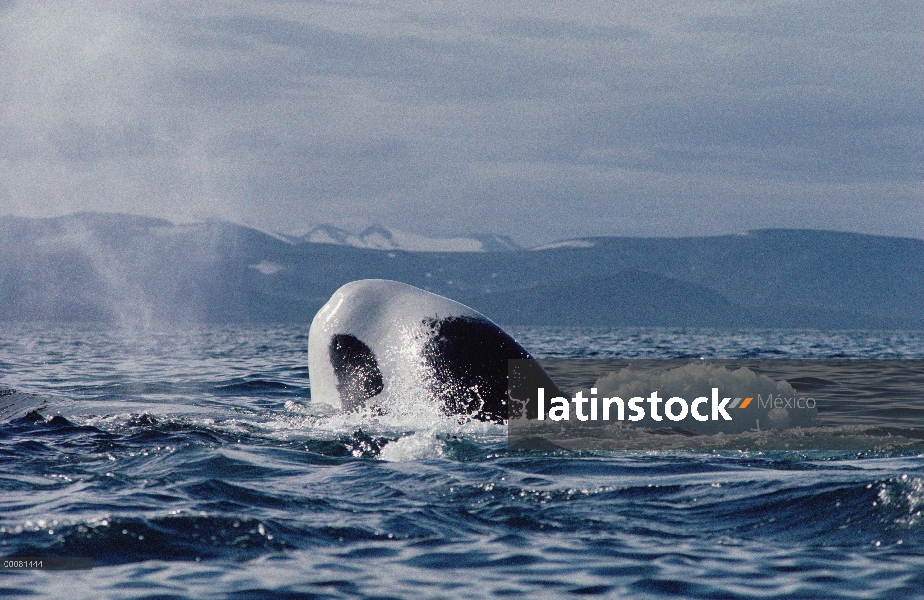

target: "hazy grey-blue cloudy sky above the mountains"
[0,0,924,244]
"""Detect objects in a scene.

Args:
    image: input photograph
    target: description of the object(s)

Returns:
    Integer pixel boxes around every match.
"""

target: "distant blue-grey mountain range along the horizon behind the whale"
[0,213,924,329]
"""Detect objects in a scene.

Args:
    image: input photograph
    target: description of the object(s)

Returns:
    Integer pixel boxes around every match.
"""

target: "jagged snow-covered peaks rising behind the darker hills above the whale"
[298,225,519,252]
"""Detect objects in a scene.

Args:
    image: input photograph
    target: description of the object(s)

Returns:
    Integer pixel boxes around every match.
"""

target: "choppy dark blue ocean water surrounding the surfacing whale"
[0,325,924,598]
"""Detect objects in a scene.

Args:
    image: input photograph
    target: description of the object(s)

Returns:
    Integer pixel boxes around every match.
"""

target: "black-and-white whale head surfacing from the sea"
[308,279,557,422]
